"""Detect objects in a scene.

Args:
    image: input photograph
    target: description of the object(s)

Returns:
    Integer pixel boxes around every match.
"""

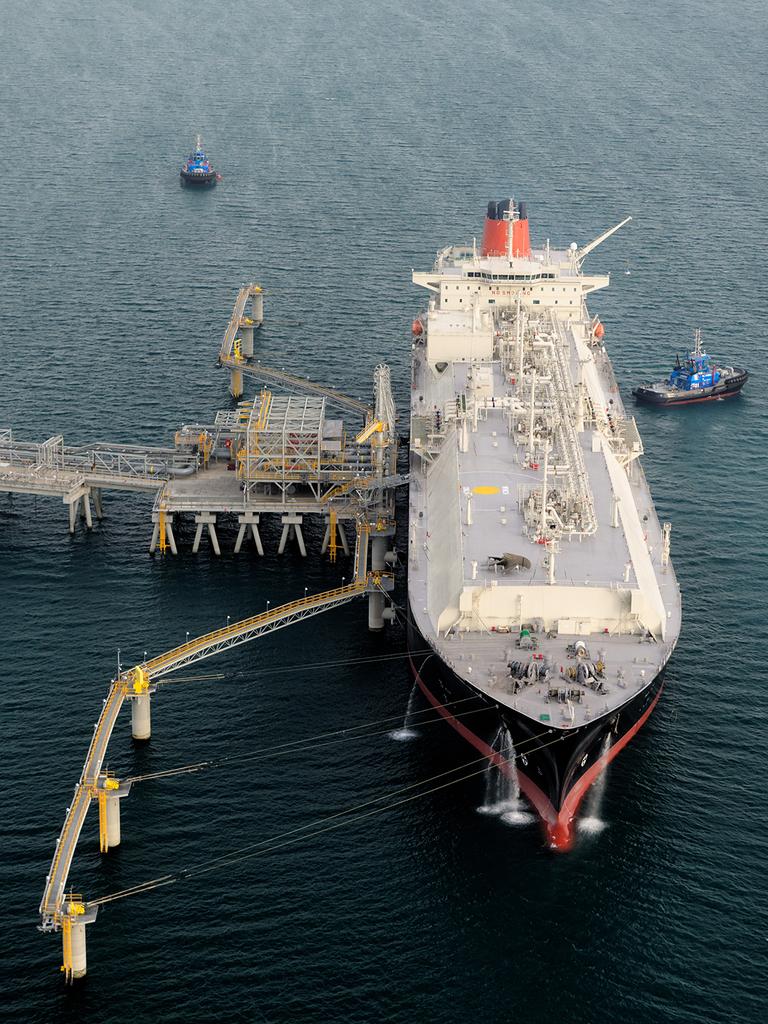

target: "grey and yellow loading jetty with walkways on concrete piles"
[0,284,407,981]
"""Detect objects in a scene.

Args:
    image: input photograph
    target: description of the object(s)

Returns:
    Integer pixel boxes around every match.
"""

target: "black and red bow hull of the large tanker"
[409,624,664,851]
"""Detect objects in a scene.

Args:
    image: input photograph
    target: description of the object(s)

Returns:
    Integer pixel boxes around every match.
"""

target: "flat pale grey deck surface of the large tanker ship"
[409,309,681,730]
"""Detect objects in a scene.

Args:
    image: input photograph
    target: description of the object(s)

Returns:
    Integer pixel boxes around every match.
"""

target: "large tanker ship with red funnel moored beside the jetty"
[409,200,681,850]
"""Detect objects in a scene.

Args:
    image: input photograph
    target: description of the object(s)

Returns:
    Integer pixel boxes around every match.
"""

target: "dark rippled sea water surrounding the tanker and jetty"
[0,0,768,1024]
